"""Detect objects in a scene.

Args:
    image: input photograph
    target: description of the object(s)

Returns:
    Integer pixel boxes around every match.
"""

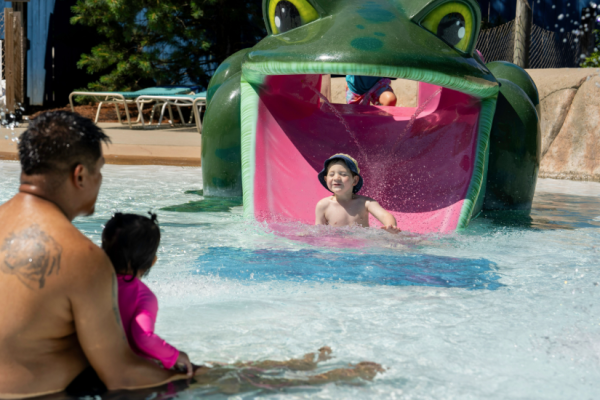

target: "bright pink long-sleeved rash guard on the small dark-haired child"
[117,275,179,368]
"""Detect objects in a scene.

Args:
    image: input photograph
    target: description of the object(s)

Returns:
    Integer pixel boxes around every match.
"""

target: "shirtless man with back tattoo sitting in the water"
[0,111,186,399]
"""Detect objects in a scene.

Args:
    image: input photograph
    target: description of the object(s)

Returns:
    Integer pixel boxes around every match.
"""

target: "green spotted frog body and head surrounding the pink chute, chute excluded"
[202,0,540,225]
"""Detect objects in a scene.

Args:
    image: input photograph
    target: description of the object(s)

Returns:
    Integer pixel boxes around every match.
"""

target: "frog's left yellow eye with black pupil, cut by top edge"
[269,0,319,34]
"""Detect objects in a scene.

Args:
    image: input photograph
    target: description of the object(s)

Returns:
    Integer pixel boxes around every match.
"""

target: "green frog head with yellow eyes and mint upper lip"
[244,0,498,98]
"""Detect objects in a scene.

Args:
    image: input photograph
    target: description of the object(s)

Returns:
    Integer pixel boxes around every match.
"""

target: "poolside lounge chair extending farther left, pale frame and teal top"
[69,86,195,128]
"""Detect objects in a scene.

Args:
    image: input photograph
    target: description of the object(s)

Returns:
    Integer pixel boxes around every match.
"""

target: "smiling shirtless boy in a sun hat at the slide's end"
[315,154,400,233]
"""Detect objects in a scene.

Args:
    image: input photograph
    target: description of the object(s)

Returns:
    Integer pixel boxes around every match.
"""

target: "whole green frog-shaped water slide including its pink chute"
[202,0,540,232]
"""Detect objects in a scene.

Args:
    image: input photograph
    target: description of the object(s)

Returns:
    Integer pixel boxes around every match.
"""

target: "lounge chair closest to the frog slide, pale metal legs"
[136,92,206,133]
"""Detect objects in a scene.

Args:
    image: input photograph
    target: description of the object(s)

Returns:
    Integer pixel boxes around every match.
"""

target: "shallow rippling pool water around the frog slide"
[0,162,600,399]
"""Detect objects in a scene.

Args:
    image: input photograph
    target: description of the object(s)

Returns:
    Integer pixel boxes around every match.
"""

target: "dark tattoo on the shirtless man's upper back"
[0,224,62,289]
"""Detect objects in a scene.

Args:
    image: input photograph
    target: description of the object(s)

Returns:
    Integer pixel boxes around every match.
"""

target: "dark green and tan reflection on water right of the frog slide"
[474,192,600,230]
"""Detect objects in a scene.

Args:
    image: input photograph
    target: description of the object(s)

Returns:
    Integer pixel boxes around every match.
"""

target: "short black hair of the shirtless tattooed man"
[19,111,110,175]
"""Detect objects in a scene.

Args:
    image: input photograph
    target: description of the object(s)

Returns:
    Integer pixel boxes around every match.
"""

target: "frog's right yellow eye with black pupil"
[421,2,475,52]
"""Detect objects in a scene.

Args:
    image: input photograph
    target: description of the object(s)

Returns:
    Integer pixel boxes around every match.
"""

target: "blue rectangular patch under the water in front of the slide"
[196,247,504,290]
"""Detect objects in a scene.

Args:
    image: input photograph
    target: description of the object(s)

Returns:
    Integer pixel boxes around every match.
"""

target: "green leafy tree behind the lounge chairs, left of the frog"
[71,0,266,91]
